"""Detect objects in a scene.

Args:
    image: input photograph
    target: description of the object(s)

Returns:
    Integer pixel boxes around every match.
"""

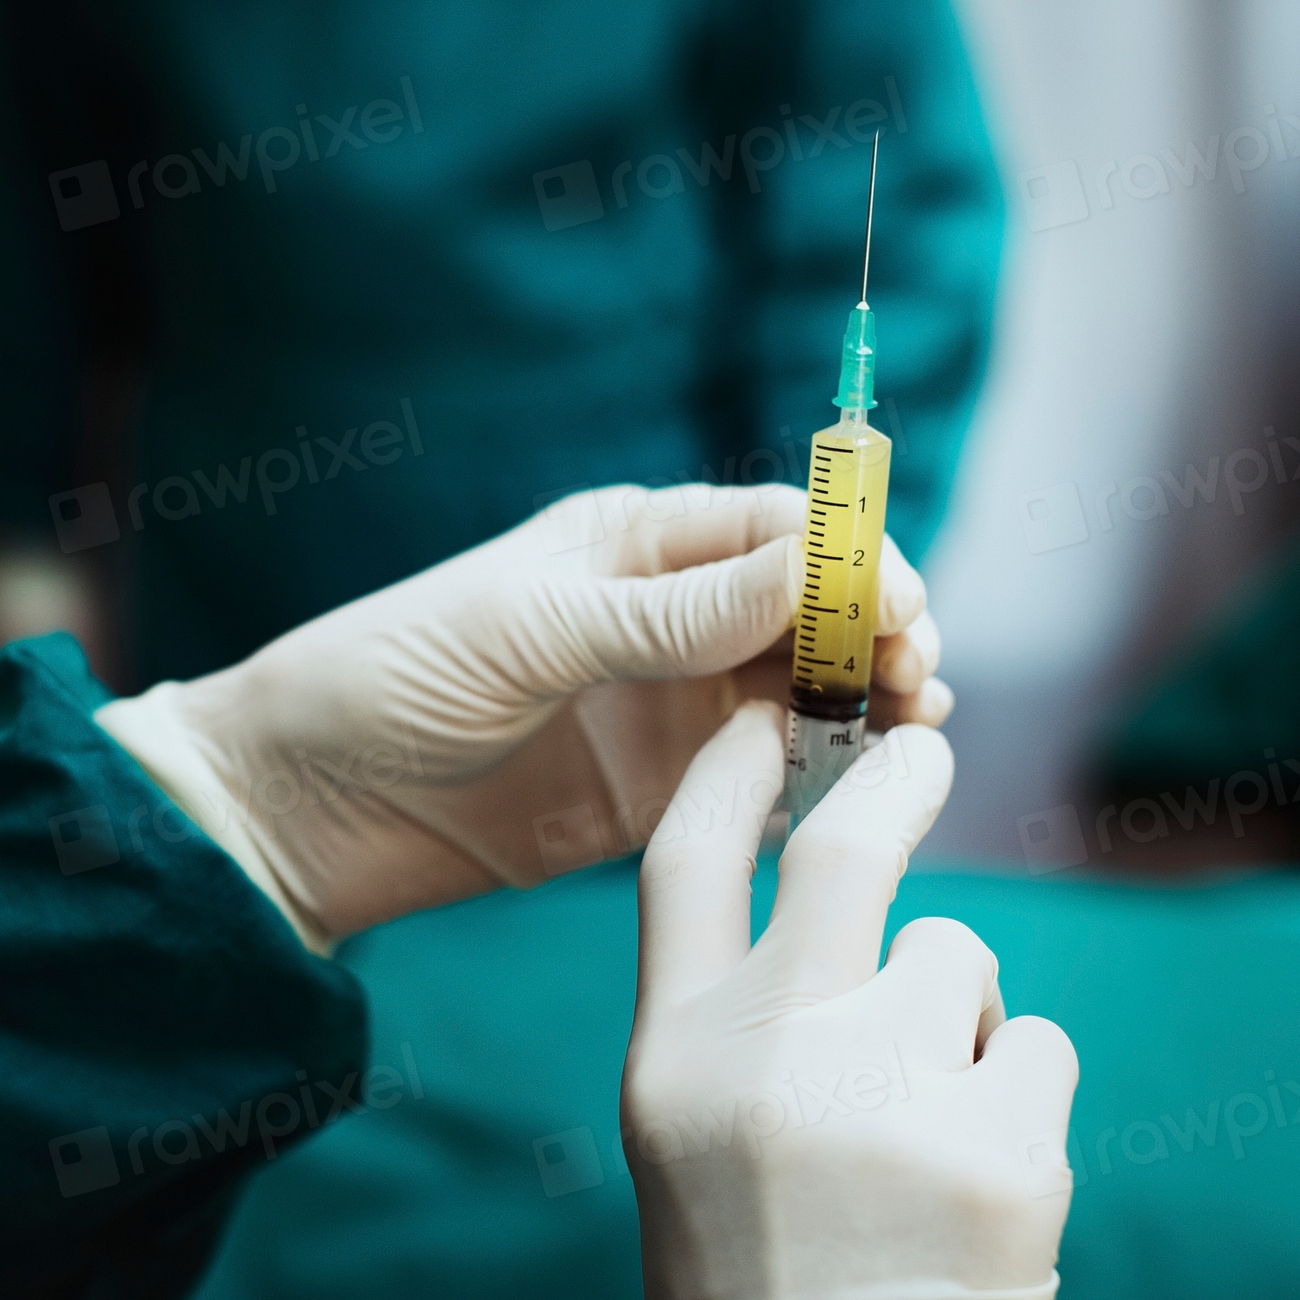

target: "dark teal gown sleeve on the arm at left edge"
[0,634,367,1297]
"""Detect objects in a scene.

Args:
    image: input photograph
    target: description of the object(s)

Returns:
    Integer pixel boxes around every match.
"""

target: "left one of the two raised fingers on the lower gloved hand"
[637,702,785,1015]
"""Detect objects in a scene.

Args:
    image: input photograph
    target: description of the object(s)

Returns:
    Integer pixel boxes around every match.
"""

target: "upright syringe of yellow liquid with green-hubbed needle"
[787,133,892,826]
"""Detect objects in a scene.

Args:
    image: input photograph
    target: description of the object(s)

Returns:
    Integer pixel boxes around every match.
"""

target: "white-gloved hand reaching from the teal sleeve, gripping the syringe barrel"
[96,485,952,949]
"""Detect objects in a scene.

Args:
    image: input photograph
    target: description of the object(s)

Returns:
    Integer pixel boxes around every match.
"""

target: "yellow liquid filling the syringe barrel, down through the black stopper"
[790,419,892,720]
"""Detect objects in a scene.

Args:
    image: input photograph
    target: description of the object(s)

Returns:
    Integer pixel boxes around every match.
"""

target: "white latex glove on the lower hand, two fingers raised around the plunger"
[623,703,1078,1300]
